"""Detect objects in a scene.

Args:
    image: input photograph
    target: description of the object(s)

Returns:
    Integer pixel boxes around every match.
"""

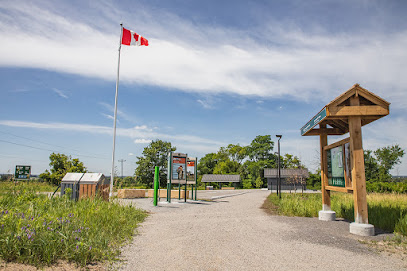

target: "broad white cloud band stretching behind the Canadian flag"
[0,1,407,106]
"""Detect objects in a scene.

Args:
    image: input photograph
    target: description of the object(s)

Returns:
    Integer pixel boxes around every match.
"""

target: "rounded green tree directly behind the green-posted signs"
[135,139,177,187]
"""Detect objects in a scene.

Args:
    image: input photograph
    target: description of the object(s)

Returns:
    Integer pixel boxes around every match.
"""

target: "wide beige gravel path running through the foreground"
[116,190,406,271]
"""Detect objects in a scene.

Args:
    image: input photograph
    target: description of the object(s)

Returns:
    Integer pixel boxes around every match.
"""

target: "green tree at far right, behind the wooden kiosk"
[364,144,404,181]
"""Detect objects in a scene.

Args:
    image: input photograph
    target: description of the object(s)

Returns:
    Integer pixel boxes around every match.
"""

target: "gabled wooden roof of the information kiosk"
[301,84,390,136]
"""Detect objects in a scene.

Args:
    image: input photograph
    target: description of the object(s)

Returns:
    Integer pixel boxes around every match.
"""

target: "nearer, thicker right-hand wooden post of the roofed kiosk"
[349,95,369,224]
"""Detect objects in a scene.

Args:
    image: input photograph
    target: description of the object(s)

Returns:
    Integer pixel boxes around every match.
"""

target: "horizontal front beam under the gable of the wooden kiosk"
[329,105,389,117]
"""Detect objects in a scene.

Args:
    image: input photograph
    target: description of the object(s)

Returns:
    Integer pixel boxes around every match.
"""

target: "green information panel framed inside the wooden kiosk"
[327,146,345,187]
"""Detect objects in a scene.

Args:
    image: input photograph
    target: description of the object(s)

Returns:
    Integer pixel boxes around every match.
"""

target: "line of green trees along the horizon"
[36,135,407,193]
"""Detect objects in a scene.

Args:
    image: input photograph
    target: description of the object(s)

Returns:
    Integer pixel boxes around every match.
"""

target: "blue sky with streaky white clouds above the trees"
[0,0,407,176]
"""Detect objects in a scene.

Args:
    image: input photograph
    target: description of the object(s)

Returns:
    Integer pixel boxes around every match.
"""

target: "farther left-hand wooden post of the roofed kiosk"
[319,124,331,211]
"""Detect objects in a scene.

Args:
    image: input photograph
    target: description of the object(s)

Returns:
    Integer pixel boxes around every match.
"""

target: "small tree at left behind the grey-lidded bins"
[40,153,87,185]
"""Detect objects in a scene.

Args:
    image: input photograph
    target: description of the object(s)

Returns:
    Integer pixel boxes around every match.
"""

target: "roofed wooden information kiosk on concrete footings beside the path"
[301,84,390,236]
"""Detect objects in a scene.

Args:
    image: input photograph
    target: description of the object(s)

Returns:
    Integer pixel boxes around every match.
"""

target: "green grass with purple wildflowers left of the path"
[0,186,147,267]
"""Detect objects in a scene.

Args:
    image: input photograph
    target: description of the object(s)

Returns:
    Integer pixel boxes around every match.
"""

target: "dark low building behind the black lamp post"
[264,168,309,190]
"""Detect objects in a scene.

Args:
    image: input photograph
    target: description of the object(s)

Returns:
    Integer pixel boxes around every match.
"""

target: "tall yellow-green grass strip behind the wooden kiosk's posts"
[267,193,407,236]
